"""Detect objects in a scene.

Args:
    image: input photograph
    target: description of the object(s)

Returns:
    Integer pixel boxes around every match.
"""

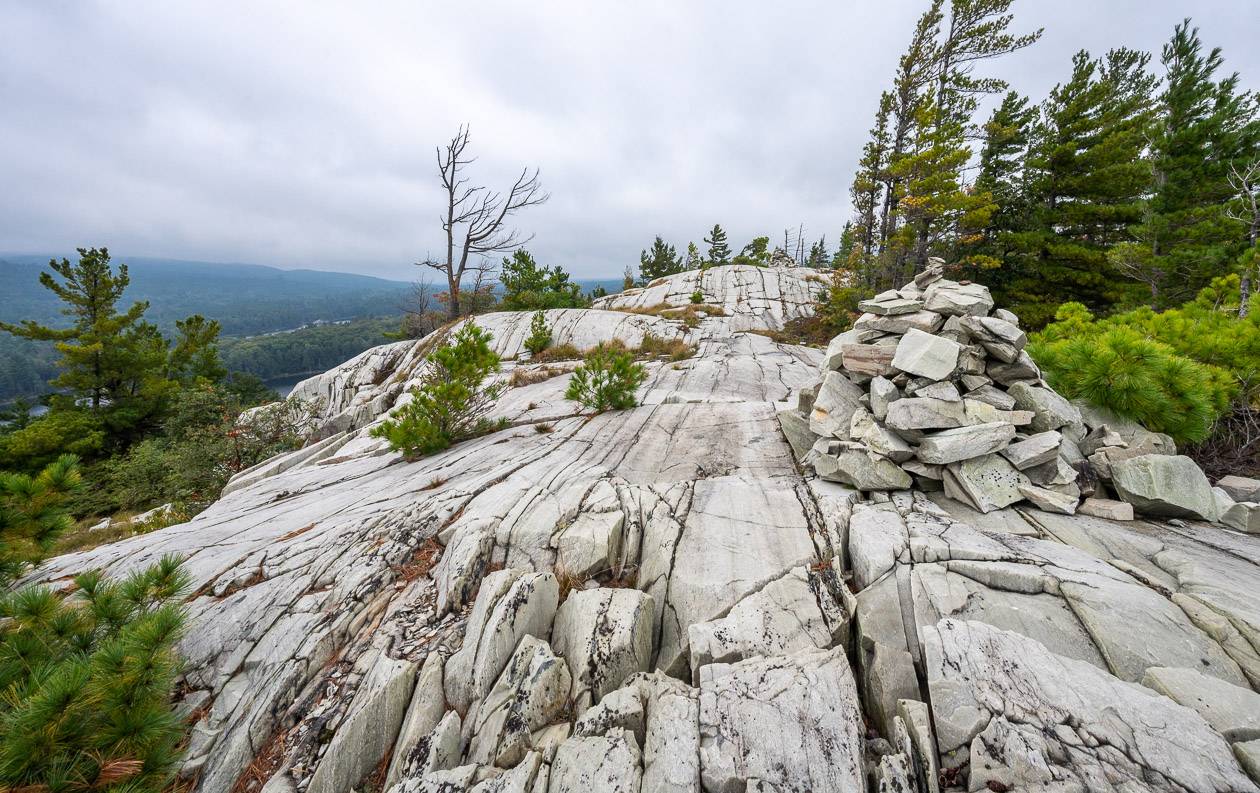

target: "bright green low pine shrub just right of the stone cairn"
[1028,276,1260,443]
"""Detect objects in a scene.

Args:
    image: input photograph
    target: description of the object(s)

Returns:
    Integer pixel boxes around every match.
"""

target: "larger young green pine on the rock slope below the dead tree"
[372,321,503,459]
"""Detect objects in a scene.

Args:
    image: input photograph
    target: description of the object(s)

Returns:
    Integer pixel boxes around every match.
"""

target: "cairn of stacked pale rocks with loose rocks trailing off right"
[780,260,1260,531]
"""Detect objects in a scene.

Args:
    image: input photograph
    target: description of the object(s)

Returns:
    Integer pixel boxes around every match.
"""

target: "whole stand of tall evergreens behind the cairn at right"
[842,0,1260,327]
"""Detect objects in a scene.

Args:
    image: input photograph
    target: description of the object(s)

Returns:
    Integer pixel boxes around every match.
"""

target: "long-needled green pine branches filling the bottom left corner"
[0,557,188,793]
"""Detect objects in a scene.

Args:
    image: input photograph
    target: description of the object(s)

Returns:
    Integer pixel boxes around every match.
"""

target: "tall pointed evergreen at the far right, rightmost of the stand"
[1111,19,1260,309]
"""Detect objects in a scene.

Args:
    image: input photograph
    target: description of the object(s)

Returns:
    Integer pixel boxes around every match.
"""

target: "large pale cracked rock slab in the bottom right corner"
[920,619,1256,793]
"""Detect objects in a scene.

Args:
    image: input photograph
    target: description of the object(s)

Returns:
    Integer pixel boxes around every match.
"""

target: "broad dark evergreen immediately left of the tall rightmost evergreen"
[1009,49,1154,327]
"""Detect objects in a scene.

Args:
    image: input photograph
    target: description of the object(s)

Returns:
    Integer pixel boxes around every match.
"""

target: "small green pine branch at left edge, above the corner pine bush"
[0,454,82,588]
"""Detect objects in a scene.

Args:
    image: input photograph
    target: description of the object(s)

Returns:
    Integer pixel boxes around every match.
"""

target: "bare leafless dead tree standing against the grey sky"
[420,125,551,319]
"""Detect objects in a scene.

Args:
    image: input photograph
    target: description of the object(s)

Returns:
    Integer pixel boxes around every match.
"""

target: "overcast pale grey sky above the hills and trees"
[0,0,1260,280]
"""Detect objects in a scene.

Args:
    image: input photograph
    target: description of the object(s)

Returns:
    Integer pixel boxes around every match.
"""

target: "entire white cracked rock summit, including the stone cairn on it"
[24,262,1260,793]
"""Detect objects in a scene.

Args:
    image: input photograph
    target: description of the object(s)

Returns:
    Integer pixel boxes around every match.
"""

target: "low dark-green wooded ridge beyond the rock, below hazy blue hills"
[219,316,398,379]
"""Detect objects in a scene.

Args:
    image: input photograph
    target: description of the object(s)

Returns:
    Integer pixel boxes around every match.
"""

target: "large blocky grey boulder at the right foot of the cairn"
[1111,454,1218,521]
